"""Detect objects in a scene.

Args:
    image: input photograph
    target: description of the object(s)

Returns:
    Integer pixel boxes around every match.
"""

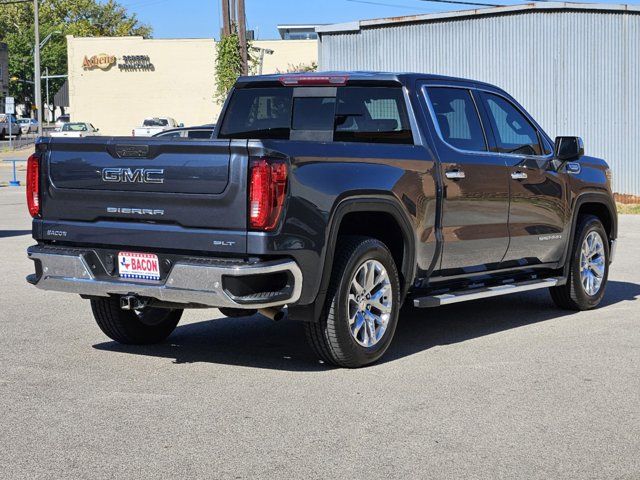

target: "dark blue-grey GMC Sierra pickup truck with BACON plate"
[27,72,617,367]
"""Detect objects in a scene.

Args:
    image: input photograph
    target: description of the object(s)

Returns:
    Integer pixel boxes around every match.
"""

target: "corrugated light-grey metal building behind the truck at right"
[316,2,640,196]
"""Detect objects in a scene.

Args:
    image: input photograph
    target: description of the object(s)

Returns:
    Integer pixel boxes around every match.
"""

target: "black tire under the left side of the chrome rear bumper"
[91,297,182,345]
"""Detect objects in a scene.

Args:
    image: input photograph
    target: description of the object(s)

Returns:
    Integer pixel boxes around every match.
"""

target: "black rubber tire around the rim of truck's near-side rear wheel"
[305,236,401,368]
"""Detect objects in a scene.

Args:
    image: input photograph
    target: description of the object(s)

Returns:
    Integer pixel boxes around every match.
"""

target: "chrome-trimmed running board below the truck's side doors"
[413,277,563,308]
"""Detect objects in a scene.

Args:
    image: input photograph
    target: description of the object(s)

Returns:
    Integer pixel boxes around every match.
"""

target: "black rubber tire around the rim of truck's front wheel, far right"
[549,215,609,311]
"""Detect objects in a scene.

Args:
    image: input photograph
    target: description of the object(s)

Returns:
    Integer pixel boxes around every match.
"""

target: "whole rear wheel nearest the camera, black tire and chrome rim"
[305,237,400,368]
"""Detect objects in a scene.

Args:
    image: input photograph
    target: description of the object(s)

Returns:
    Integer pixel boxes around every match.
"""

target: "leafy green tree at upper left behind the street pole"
[0,0,152,114]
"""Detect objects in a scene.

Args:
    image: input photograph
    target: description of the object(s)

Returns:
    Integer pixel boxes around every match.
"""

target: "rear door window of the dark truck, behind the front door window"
[427,87,487,152]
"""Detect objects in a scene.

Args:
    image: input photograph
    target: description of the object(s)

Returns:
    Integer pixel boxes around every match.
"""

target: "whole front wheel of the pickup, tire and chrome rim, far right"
[550,215,609,310]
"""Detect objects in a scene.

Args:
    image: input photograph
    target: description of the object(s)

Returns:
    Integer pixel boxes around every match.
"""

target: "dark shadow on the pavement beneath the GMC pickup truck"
[94,281,640,371]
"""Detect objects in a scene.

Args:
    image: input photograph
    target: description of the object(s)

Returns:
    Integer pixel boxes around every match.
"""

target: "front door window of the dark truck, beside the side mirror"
[482,92,542,155]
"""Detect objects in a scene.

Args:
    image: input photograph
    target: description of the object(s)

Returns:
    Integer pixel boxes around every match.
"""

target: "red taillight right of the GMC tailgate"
[249,158,287,231]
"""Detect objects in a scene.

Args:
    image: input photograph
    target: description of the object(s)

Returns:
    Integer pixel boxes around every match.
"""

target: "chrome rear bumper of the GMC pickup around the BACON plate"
[27,245,302,309]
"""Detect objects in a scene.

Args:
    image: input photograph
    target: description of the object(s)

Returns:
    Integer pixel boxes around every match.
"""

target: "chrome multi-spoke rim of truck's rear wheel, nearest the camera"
[348,260,393,347]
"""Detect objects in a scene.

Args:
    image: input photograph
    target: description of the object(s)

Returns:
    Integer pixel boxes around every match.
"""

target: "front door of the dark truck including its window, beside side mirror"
[480,91,569,267]
